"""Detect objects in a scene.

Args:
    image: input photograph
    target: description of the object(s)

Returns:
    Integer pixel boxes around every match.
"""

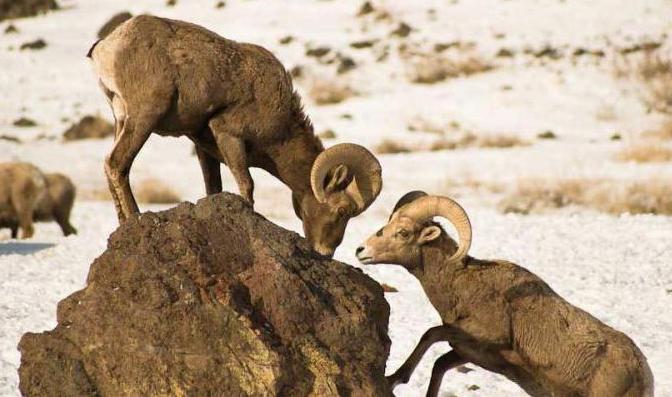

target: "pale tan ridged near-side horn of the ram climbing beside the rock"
[403,196,471,261]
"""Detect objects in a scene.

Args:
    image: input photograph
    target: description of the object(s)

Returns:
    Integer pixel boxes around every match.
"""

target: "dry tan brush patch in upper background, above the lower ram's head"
[406,53,493,84]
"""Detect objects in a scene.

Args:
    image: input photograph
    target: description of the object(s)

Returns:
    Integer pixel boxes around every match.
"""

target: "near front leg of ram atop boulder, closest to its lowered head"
[210,123,254,206]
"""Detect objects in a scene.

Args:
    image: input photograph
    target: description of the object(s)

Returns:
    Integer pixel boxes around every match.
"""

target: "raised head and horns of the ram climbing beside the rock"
[356,191,471,269]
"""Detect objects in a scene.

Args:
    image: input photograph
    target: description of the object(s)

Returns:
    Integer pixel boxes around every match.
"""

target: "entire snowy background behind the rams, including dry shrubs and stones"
[0,0,672,396]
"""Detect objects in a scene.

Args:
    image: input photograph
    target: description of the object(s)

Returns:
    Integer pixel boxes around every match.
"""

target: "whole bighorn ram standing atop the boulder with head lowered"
[89,15,382,255]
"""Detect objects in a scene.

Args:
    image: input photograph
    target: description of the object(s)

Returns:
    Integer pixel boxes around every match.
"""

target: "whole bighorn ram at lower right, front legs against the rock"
[357,191,653,397]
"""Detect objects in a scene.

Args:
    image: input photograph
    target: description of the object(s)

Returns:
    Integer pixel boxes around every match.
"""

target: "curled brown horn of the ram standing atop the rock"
[310,143,383,214]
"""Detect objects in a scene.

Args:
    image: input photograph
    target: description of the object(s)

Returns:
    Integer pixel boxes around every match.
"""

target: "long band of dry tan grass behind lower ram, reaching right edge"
[499,179,672,215]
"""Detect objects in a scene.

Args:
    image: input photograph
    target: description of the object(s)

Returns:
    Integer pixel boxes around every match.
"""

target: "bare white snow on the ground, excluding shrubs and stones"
[0,0,672,396]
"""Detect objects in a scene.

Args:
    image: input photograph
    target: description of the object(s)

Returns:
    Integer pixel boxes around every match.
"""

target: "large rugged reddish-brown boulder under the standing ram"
[19,193,391,396]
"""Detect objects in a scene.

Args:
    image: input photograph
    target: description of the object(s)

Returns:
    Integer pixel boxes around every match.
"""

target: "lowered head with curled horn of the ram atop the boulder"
[292,143,382,257]
